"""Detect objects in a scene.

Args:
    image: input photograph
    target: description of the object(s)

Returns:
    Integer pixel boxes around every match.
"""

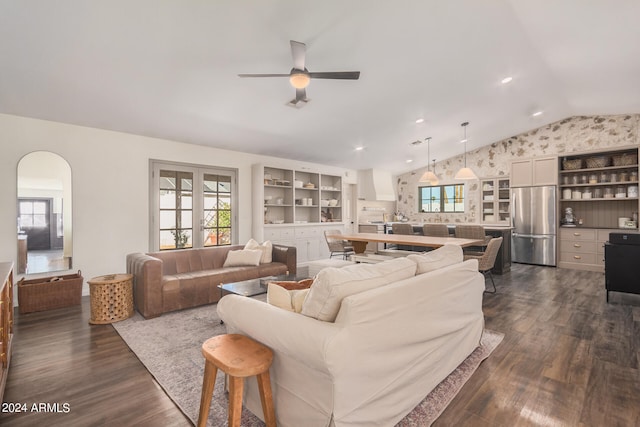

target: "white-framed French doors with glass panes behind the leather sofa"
[150,160,238,251]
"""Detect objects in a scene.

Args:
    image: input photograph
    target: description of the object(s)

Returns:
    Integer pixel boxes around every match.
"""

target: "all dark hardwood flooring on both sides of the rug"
[0,264,640,426]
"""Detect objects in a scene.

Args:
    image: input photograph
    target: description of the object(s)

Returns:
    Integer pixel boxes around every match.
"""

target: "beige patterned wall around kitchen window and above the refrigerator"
[398,114,640,223]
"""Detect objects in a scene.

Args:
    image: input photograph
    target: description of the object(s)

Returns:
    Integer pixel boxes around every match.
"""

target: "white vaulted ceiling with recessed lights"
[0,0,640,174]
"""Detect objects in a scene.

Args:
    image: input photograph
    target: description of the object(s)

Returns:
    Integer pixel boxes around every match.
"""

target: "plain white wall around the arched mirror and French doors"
[0,114,356,294]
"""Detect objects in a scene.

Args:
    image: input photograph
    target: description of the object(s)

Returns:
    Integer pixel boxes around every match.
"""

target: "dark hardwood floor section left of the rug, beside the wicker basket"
[0,297,191,427]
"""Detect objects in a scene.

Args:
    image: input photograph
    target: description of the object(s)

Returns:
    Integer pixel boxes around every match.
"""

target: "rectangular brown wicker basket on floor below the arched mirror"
[18,270,82,314]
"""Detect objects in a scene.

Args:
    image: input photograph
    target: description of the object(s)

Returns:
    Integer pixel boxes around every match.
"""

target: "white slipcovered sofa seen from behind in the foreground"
[218,248,484,427]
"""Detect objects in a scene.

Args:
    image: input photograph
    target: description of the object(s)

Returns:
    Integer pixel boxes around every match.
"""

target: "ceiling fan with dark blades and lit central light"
[238,40,360,106]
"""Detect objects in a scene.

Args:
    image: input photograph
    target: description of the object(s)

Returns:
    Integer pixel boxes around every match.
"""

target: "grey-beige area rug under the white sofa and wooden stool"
[113,305,504,427]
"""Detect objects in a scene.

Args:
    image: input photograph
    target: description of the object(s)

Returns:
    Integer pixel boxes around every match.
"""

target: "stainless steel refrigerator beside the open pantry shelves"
[511,186,558,266]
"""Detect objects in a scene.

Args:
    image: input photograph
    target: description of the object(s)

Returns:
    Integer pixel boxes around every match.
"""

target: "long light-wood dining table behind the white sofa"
[327,233,485,254]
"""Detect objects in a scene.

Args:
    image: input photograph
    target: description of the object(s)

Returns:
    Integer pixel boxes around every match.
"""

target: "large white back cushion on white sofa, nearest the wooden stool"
[301,258,417,322]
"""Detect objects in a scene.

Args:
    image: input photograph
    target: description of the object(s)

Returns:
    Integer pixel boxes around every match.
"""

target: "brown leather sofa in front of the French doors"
[127,244,296,319]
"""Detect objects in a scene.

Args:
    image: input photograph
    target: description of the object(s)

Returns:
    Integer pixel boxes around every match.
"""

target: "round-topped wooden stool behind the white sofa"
[198,334,276,427]
